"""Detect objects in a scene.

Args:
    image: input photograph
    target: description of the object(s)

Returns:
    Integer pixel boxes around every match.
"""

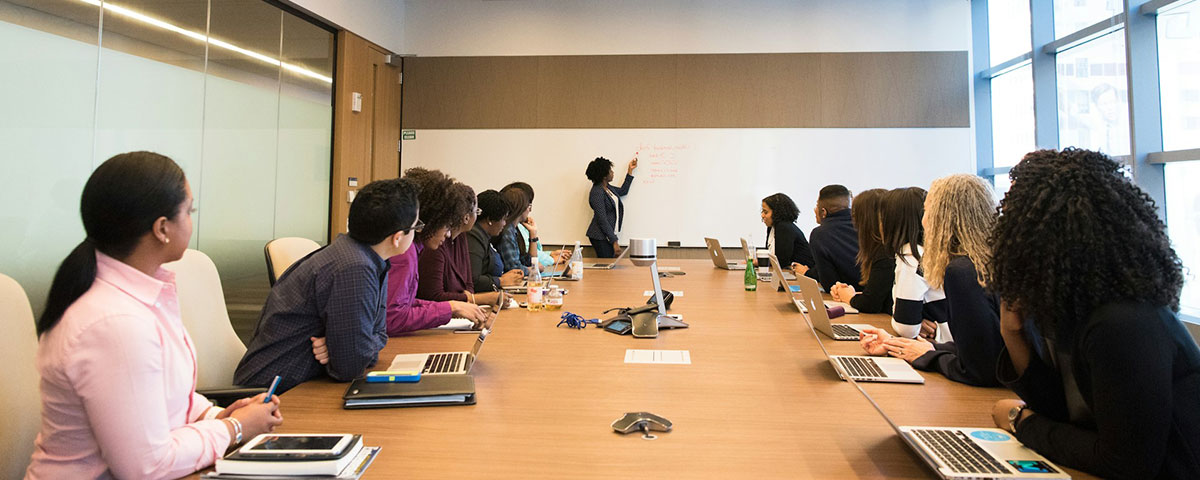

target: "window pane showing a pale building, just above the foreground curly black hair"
[1056,29,1129,156]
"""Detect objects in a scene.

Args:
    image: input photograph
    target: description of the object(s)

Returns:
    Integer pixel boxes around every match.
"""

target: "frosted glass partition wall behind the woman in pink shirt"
[0,0,335,329]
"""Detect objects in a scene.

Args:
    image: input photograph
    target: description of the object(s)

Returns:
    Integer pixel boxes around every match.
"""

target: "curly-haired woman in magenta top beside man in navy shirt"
[388,168,487,336]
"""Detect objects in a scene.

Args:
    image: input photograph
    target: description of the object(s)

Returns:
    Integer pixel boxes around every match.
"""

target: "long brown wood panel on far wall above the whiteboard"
[402,52,970,128]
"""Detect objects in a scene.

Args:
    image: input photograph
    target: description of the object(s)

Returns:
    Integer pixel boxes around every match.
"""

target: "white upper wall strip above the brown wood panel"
[400,0,971,56]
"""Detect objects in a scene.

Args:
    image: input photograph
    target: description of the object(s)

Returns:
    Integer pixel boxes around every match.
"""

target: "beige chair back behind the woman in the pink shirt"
[0,274,42,479]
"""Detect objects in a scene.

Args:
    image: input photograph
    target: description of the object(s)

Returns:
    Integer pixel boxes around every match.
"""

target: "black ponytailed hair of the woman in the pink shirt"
[37,151,187,335]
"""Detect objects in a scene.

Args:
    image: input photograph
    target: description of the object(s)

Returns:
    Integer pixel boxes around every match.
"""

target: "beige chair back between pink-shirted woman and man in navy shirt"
[162,248,246,389]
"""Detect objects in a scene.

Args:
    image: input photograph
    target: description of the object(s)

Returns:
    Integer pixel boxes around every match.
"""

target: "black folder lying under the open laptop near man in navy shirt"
[342,374,475,409]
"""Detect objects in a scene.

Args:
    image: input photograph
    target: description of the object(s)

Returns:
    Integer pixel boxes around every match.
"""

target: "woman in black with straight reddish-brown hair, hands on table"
[829,188,896,314]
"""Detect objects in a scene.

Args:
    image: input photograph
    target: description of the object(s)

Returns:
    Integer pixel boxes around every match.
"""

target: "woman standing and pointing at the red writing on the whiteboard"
[587,156,637,258]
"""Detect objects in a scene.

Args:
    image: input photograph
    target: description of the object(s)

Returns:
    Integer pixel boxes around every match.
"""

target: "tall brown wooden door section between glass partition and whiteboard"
[329,30,401,240]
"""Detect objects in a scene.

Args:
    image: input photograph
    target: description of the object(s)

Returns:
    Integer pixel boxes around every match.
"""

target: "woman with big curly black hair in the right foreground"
[989,149,1200,479]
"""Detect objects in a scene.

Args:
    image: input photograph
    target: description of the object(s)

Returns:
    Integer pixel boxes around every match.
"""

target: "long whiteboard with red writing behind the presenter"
[401,128,974,248]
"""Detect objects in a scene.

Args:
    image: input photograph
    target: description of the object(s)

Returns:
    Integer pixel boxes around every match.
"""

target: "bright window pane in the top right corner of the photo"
[1158,1,1200,151]
